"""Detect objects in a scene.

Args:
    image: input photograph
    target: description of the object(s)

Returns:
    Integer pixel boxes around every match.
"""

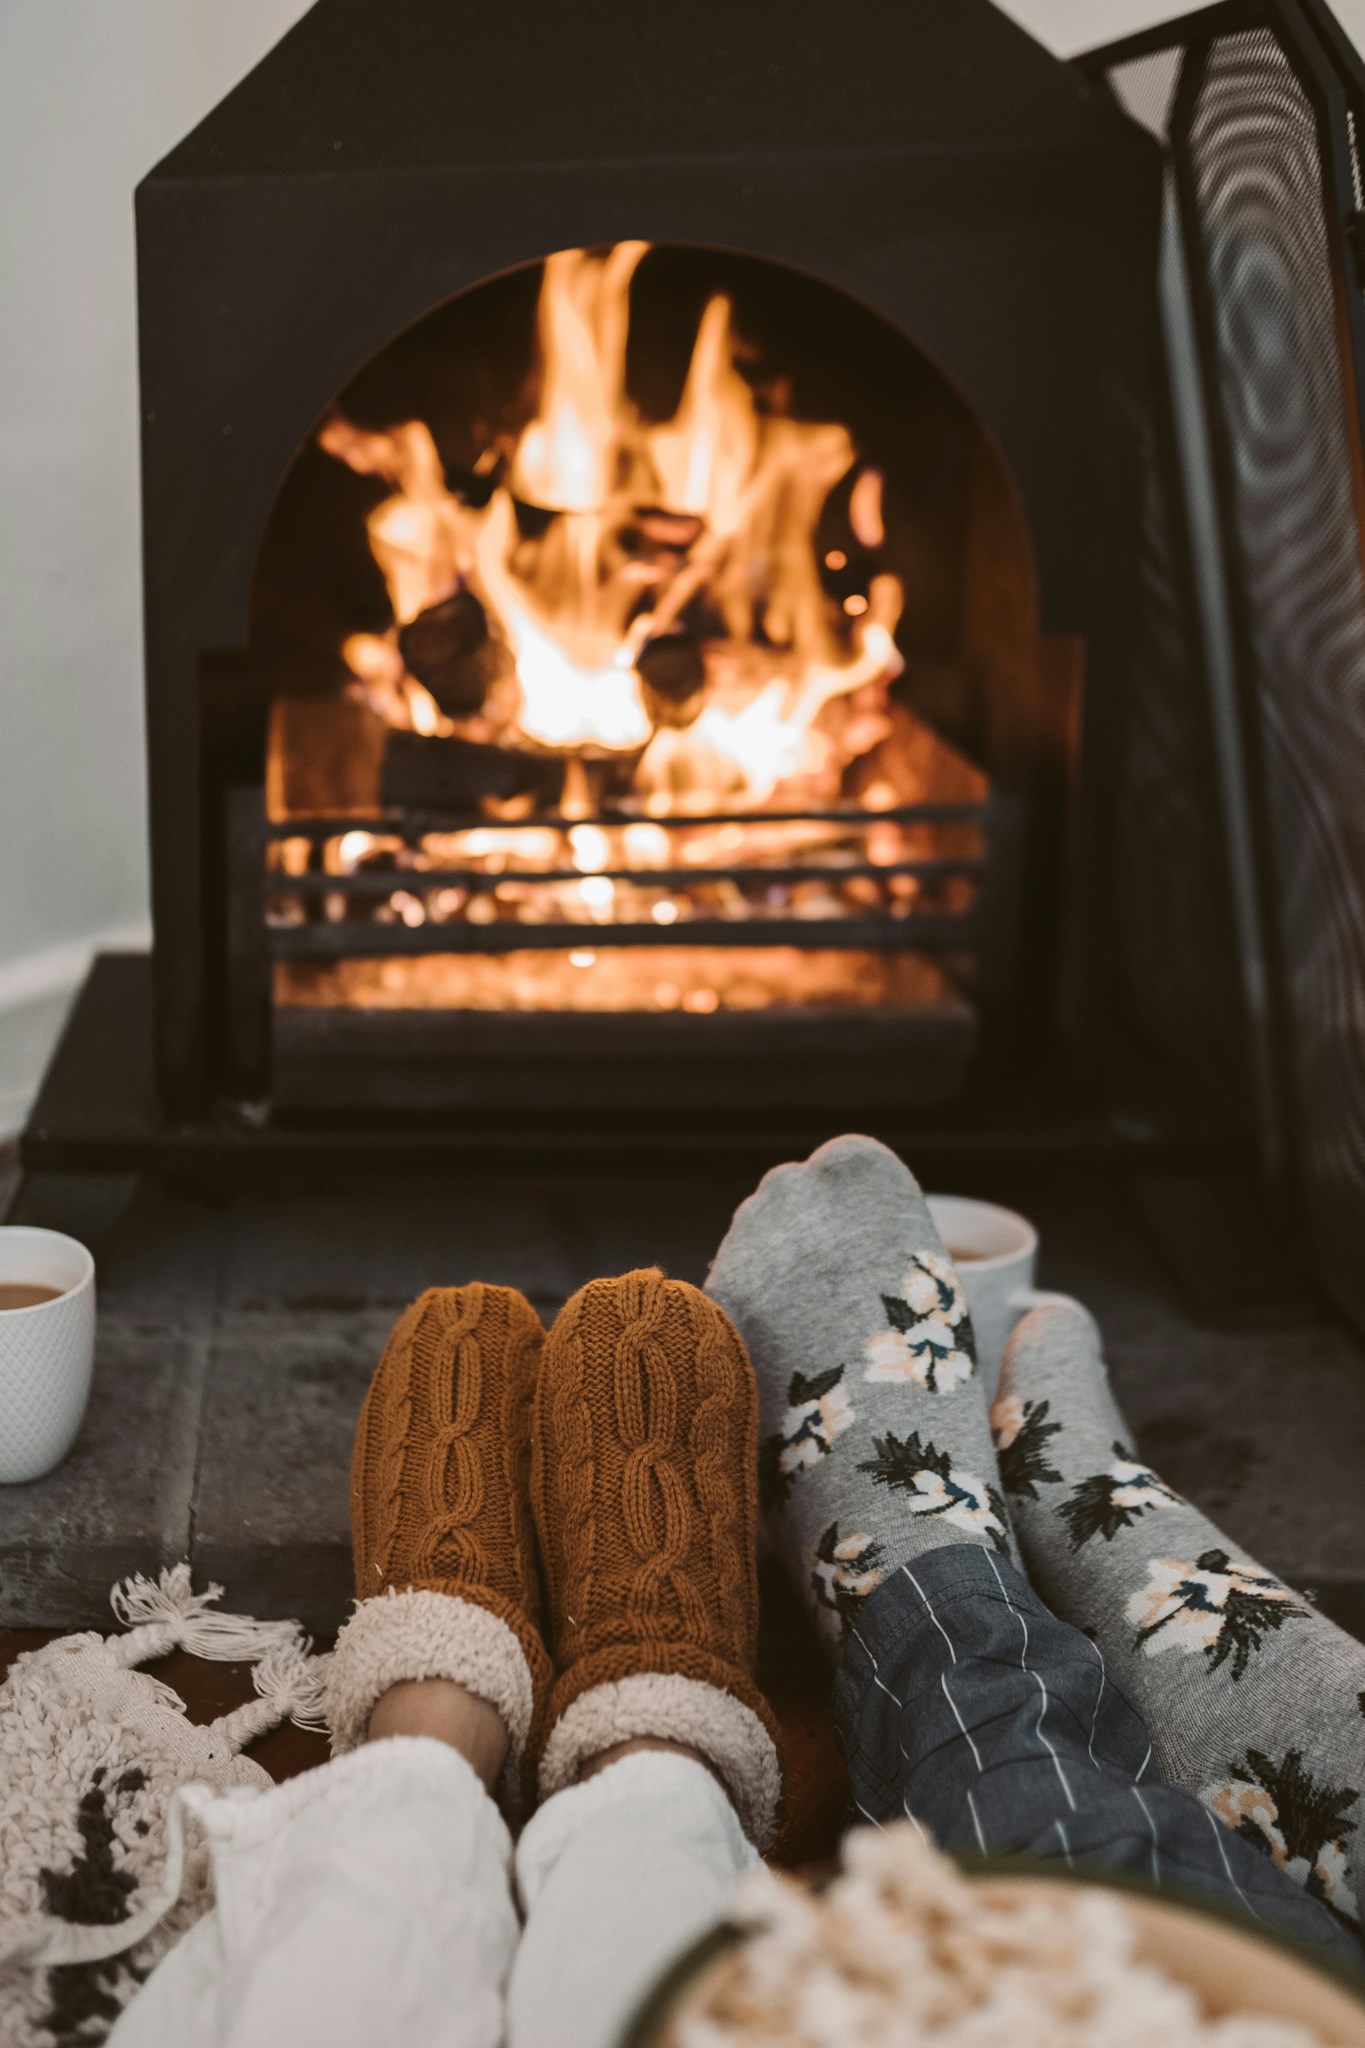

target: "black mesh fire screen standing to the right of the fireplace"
[1093,4,1365,1319]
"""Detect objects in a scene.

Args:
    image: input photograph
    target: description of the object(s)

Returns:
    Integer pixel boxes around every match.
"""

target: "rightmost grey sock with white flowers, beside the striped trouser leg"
[990,1305,1365,1923]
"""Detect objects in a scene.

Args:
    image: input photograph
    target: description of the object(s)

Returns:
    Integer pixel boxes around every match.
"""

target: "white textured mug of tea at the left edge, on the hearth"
[0,1225,94,1487]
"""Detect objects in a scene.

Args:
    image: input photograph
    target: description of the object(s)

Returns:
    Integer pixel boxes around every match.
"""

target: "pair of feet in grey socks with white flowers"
[706,1137,1365,1923]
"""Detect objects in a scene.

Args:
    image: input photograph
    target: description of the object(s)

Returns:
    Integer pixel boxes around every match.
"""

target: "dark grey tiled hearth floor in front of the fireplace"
[0,1167,1365,1859]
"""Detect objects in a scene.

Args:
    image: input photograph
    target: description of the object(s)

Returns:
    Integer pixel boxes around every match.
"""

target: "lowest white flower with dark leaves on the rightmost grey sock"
[1199,1749,1361,1921]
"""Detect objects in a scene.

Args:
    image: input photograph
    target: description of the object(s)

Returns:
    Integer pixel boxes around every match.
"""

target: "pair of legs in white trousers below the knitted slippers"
[111,1737,755,2048]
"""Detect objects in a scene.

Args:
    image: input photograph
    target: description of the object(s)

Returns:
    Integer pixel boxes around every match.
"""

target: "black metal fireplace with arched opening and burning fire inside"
[109,0,1160,1128]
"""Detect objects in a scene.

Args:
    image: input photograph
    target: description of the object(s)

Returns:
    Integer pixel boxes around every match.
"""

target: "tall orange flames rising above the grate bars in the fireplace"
[319,242,902,782]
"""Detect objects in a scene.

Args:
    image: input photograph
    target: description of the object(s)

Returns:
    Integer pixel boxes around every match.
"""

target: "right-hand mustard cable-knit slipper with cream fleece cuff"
[532,1270,780,1847]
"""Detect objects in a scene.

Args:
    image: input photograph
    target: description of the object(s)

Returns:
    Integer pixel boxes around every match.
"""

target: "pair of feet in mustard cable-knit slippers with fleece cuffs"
[329,1270,780,1843]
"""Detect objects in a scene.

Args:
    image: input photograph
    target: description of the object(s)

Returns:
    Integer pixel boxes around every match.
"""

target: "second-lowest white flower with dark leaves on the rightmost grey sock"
[1126,1550,1304,1681]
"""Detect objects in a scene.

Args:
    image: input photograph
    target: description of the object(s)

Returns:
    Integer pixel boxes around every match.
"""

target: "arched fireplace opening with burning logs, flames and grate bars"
[237,242,1031,1073]
